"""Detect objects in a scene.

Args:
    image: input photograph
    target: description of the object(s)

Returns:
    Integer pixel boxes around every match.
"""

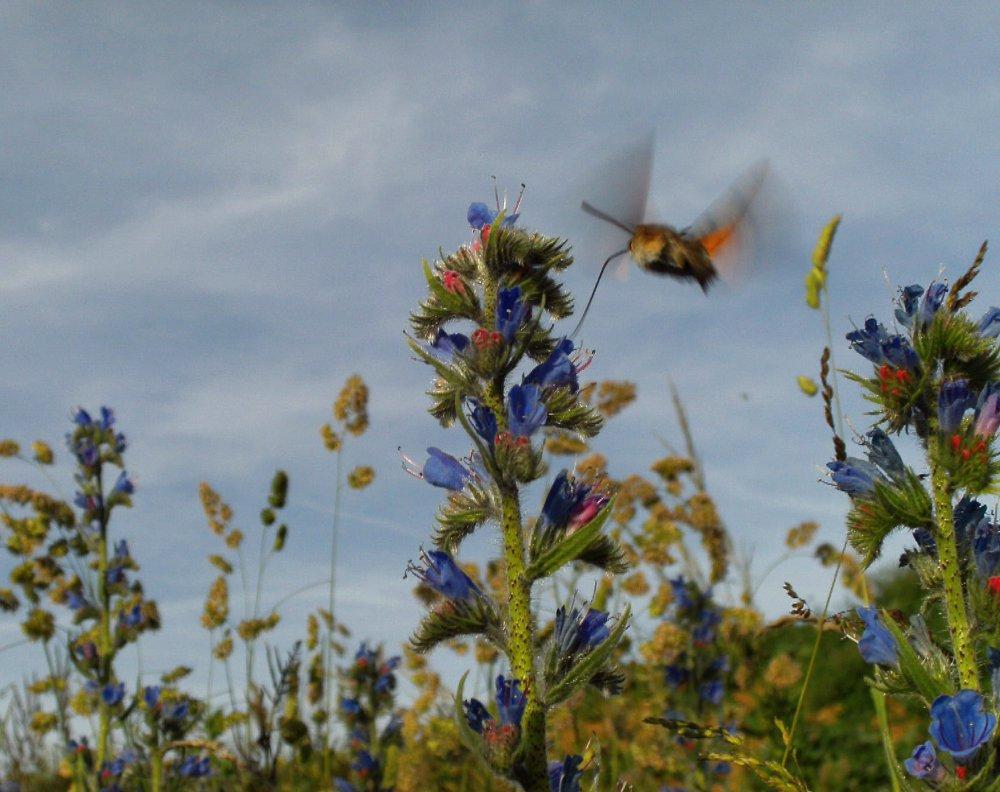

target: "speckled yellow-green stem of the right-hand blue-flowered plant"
[928,431,979,690]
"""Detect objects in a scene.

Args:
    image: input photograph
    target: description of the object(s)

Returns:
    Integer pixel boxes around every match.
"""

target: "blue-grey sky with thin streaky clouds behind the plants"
[0,2,1000,704]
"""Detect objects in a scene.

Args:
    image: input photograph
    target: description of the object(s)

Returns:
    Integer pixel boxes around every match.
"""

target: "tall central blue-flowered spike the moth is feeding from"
[406,196,629,792]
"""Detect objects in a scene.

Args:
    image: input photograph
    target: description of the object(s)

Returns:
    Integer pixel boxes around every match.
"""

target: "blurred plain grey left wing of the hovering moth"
[584,132,655,228]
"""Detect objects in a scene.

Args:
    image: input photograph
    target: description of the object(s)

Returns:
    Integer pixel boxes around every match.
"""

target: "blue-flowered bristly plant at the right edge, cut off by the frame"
[828,244,1000,789]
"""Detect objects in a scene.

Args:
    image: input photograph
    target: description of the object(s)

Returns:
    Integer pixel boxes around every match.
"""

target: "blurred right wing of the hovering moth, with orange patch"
[685,161,770,279]
